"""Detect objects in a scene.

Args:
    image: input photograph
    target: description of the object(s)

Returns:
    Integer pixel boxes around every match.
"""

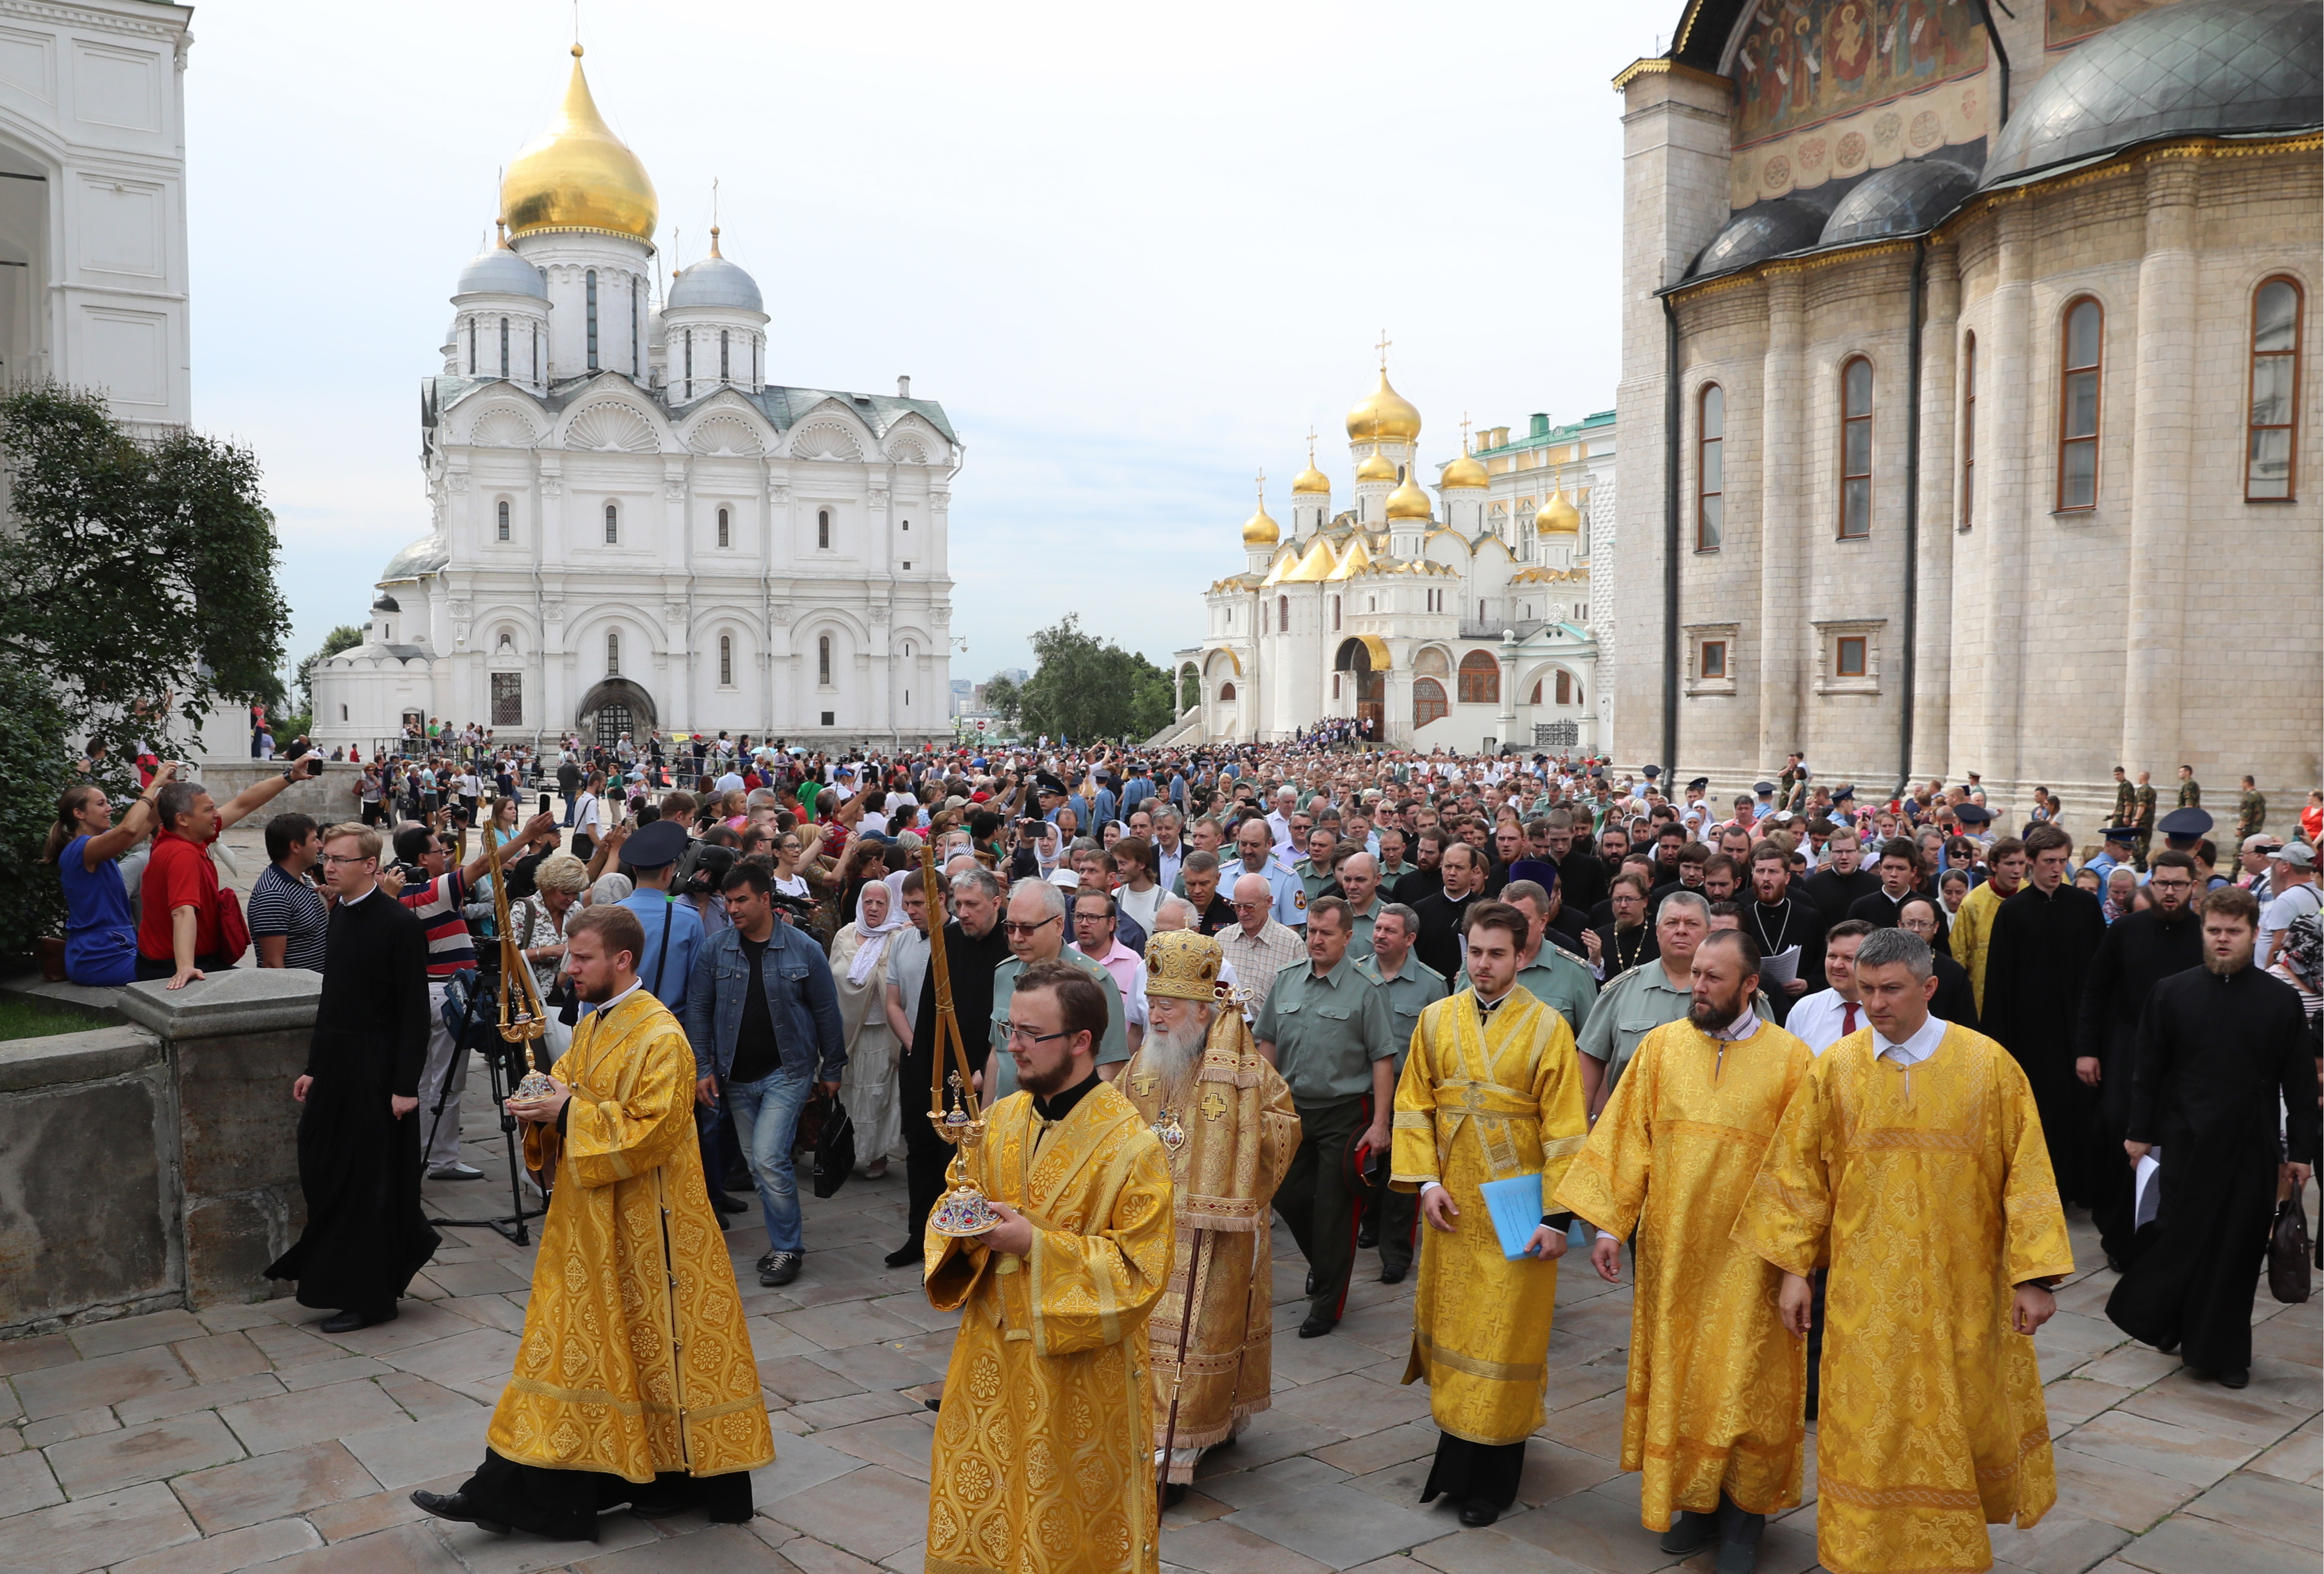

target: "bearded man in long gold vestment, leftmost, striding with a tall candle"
[412,907,774,1542]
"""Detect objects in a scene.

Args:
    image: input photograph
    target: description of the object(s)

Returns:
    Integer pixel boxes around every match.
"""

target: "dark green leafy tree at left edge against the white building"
[0,386,291,760]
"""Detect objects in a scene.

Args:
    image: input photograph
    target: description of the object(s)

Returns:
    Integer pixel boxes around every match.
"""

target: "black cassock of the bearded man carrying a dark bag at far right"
[2106,967,2317,1372]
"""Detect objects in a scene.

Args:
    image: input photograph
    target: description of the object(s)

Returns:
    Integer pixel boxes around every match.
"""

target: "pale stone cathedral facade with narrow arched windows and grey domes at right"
[1613,0,2324,828]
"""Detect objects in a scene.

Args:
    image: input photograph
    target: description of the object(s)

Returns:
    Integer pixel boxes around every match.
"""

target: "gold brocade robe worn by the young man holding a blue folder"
[1390,988,1589,1444]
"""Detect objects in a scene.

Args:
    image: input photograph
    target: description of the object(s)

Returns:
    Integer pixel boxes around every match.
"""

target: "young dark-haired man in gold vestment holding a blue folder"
[1390,902,1587,1525]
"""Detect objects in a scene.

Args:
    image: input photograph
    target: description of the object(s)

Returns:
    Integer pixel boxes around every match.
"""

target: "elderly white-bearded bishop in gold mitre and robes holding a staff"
[1113,930,1299,1502]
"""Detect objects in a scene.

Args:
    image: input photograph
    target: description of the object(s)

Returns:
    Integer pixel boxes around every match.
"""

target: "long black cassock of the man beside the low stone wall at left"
[267,891,439,1316]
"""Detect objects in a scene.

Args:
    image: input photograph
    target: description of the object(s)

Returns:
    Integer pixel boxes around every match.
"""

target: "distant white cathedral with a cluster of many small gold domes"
[1173,363,1615,751]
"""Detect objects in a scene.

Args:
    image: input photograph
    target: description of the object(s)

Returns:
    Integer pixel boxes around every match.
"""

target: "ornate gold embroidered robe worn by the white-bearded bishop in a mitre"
[1113,1007,1299,1481]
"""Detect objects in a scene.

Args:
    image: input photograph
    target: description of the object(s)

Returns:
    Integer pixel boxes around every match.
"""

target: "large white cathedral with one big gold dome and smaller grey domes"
[312,44,962,751]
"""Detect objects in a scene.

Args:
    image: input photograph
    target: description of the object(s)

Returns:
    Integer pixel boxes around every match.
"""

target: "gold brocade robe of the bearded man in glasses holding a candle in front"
[927,1084,1171,1574]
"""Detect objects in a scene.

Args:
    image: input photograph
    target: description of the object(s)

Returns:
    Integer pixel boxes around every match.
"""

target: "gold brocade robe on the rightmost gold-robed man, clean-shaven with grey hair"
[1736,1027,2073,1574]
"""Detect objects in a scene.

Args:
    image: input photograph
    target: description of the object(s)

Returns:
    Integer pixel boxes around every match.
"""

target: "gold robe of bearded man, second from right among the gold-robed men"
[1557,1018,1815,1530]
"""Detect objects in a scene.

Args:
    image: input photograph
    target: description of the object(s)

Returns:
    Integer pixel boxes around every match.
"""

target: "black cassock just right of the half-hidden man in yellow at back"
[1980,881,2106,1207]
